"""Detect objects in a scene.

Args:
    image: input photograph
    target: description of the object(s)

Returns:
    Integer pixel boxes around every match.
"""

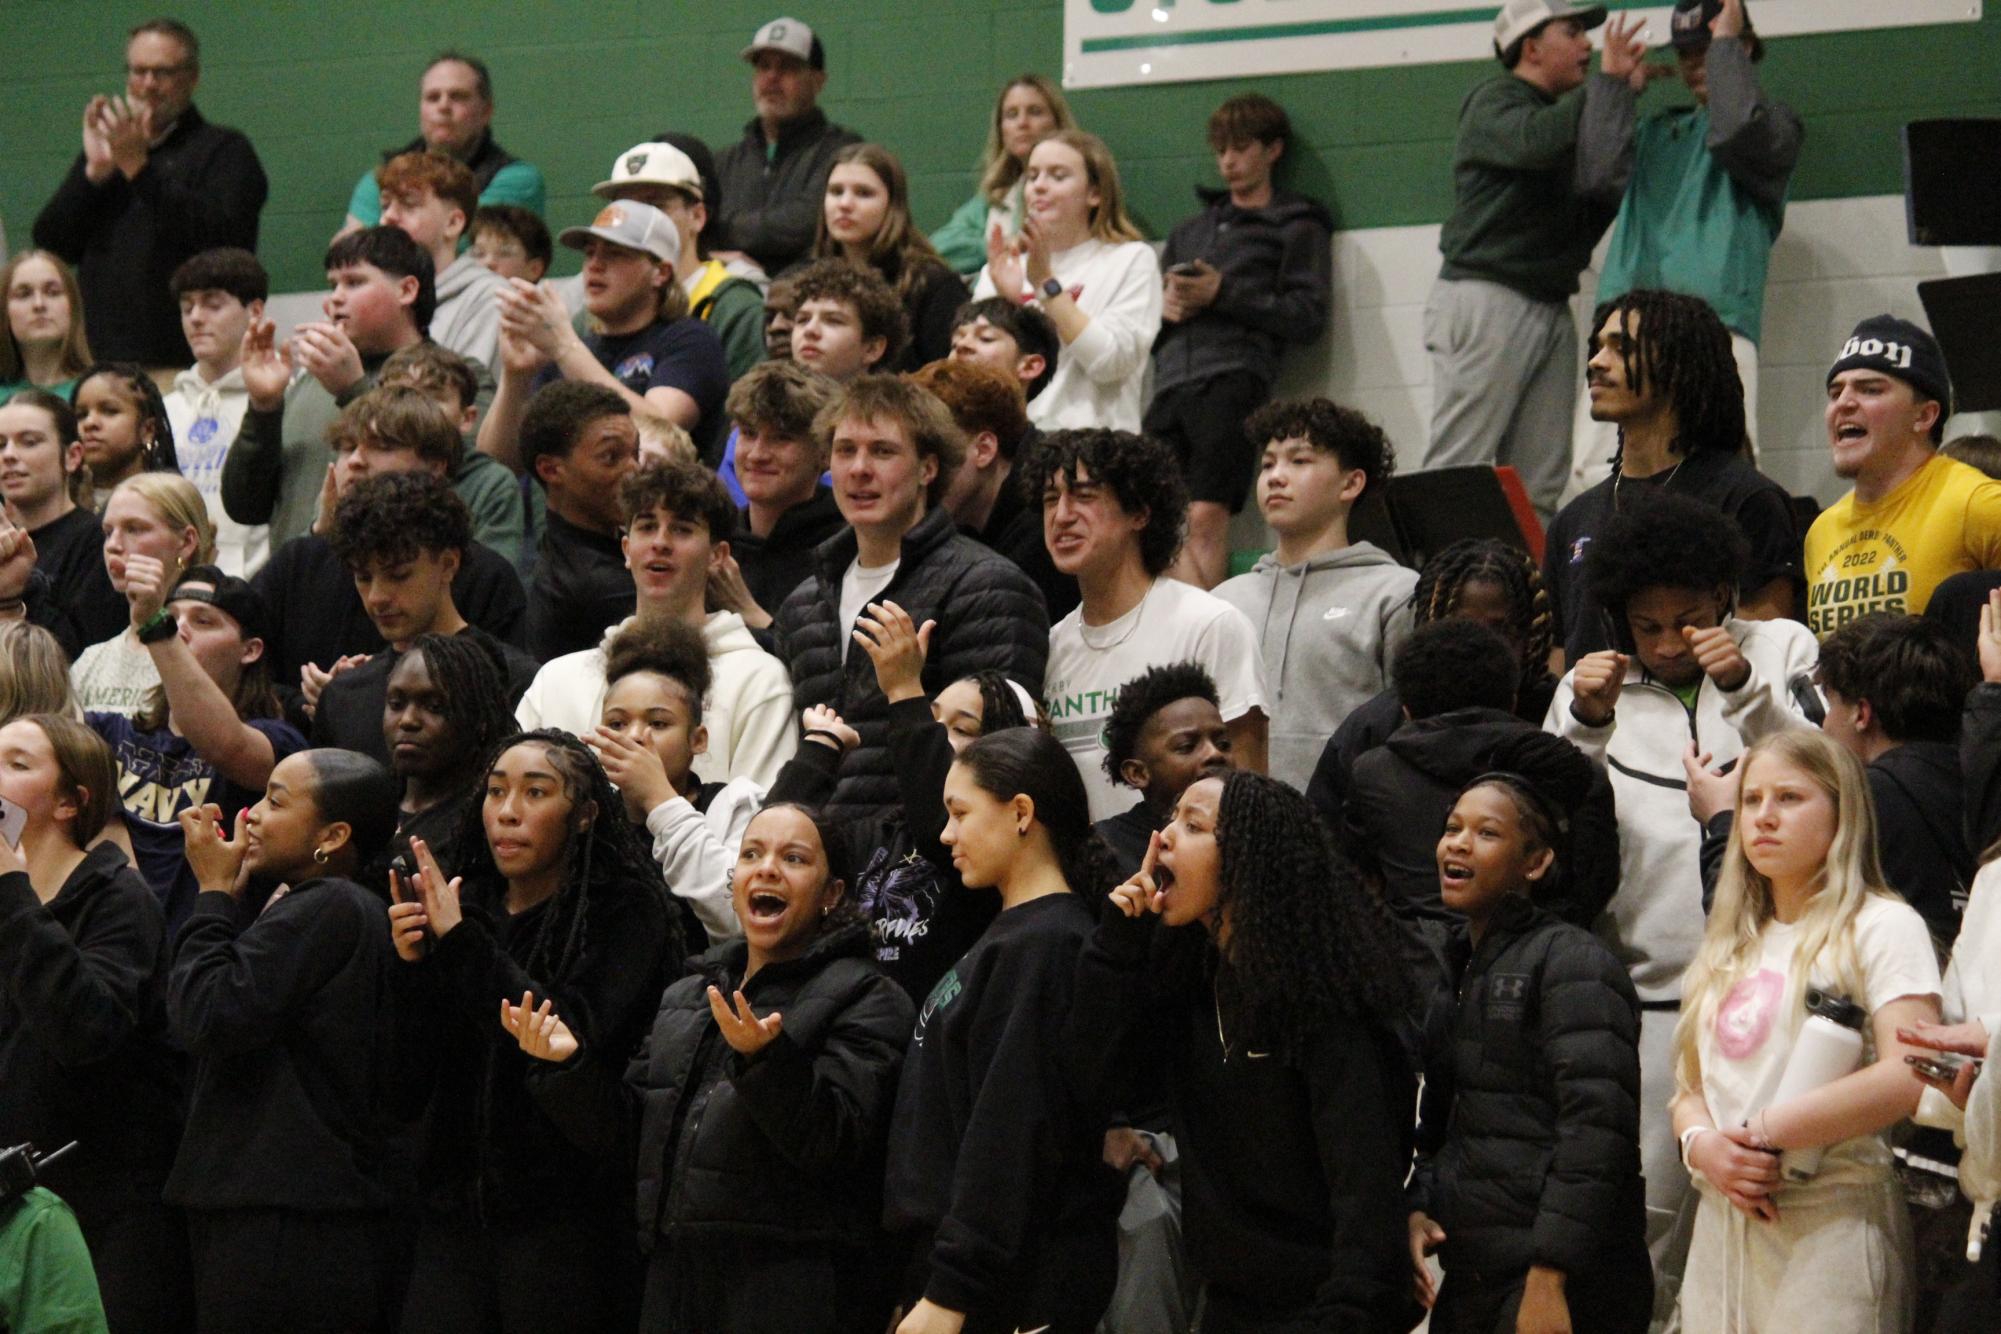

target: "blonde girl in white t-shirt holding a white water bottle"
[1673,730,1939,1334]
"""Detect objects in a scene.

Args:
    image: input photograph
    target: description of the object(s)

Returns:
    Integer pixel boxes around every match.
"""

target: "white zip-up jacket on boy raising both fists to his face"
[1543,620,1821,1002]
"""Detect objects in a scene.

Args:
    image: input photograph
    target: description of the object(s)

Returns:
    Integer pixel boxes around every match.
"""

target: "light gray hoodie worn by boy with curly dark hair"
[1217,542,1417,792]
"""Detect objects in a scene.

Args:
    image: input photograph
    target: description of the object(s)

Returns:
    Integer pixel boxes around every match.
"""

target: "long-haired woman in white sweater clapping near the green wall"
[972,130,1161,432]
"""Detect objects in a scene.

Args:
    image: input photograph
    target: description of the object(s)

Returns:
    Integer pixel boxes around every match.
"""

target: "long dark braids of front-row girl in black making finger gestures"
[452,732,684,984]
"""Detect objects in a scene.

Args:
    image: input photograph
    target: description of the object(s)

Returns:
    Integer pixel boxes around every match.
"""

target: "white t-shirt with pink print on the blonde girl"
[1697,896,1939,1186]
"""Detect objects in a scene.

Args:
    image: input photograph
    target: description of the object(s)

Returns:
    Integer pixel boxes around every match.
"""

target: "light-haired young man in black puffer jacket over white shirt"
[778,376,1049,820]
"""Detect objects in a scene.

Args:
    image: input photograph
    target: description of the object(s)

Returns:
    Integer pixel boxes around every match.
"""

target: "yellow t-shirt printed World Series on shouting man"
[1807,454,2001,640]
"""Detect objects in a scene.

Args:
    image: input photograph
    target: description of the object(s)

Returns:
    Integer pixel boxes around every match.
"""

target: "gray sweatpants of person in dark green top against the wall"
[1425,278,1581,524]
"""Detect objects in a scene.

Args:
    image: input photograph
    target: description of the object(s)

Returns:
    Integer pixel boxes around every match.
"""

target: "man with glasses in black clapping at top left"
[34,18,268,368]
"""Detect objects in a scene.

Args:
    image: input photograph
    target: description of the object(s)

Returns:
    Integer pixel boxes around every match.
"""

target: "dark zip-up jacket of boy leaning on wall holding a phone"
[1153,186,1335,394]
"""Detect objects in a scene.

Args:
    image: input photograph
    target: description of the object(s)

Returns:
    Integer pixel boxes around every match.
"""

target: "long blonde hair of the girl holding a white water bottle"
[1675,728,1895,1094]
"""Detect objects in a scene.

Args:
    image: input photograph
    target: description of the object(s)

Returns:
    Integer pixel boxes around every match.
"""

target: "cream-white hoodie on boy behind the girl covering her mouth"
[514,612,798,786]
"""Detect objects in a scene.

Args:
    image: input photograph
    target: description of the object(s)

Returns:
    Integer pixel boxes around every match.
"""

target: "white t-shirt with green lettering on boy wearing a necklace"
[1043,578,1269,820]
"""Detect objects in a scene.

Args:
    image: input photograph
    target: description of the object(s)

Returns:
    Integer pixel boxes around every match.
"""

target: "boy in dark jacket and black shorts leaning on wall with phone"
[1147,92,1333,588]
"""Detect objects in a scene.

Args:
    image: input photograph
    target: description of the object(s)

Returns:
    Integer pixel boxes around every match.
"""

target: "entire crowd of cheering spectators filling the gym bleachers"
[0,0,2001,1334]
